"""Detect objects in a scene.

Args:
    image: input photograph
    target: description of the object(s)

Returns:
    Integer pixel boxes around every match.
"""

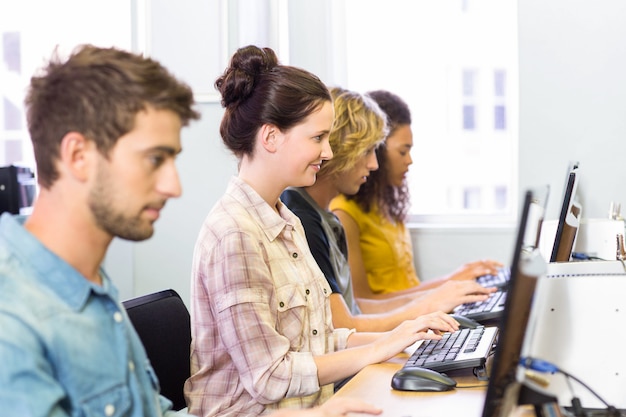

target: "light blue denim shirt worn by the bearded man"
[0,213,190,417]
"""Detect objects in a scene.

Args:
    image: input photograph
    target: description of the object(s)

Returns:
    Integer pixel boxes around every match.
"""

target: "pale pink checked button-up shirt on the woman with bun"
[185,177,351,417]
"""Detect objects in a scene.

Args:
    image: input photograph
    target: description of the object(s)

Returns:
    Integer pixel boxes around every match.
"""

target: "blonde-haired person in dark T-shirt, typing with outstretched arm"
[281,87,490,331]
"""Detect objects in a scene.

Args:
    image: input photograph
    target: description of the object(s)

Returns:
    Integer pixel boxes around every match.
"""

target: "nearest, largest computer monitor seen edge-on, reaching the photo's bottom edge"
[482,190,547,417]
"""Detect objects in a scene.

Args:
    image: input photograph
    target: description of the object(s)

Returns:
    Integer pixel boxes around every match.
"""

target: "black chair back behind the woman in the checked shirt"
[122,289,191,410]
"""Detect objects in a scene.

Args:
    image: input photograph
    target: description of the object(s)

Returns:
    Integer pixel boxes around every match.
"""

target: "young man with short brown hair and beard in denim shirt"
[0,45,199,417]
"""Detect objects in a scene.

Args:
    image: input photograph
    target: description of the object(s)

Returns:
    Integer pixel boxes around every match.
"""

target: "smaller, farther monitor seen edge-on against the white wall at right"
[550,163,582,262]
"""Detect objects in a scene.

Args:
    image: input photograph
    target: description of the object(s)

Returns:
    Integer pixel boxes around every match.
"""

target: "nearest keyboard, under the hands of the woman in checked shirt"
[404,326,498,372]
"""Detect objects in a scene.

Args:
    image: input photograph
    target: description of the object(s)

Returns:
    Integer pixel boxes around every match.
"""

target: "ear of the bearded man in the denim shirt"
[60,132,95,181]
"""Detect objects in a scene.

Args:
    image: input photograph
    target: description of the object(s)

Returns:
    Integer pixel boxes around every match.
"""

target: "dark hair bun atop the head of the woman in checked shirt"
[215,45,278,107]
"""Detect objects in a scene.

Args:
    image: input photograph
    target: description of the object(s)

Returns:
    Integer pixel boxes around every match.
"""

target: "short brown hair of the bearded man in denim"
[25,45,200,188]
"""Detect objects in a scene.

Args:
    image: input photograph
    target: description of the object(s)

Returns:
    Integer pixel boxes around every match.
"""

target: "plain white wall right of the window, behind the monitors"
[519,0,626,218]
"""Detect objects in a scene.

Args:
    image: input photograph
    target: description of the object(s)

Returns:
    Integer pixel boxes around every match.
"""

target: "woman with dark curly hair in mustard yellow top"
[329,90,501,298]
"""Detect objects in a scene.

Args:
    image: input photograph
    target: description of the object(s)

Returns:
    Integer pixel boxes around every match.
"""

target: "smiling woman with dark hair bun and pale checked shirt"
[185,46,458,417]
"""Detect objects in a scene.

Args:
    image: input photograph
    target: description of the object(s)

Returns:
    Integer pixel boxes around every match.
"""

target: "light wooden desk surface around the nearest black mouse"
[335,354,534,417]
